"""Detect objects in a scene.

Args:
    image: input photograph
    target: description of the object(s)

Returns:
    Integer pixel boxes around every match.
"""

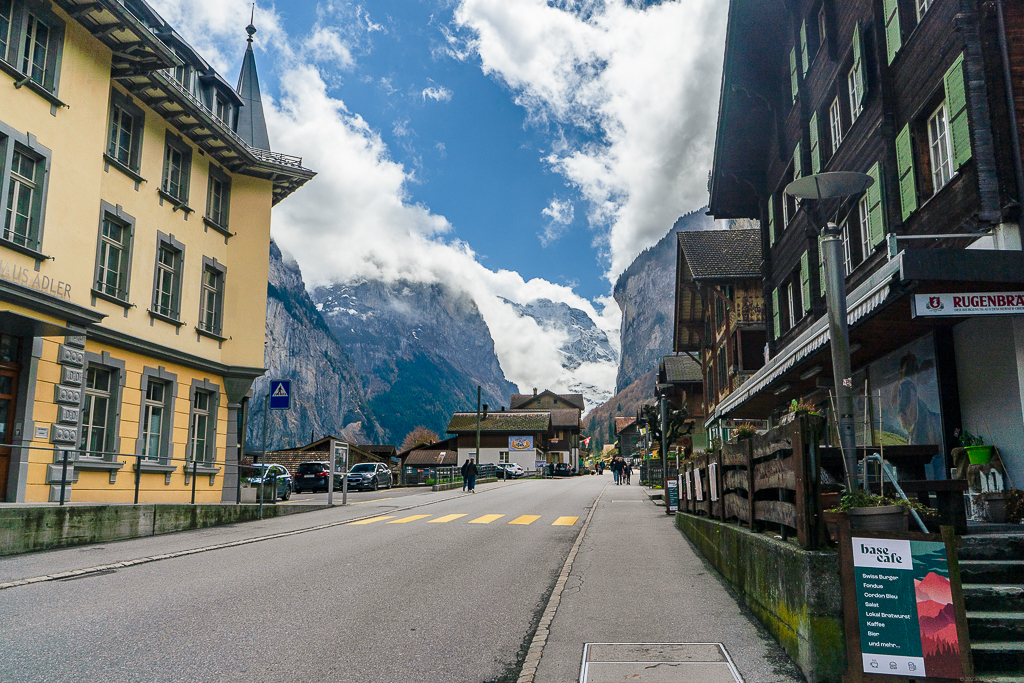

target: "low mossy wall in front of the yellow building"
[0,504,327,556]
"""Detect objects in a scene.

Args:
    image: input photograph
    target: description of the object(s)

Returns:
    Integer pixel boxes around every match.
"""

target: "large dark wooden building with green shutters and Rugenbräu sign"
[708,0,1024,481]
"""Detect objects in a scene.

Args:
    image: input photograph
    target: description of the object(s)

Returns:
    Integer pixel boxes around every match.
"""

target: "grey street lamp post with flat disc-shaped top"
[785,171,874,492]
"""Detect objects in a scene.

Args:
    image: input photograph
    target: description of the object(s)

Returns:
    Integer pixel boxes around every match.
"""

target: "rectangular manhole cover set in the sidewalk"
[580,643,743,683]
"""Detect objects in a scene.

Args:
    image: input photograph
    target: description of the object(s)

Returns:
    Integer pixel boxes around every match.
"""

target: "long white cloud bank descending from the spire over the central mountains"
[153,0,618,401]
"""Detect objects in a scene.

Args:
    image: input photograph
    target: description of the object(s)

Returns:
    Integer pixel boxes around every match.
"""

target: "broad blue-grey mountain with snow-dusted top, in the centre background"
[310,281,518,443]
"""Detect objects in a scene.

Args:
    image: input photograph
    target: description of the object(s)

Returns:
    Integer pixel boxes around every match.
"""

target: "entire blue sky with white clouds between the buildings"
[151,0,727,403]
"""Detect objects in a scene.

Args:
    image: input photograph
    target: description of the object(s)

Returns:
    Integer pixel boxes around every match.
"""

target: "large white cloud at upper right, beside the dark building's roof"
[447,0,728,282]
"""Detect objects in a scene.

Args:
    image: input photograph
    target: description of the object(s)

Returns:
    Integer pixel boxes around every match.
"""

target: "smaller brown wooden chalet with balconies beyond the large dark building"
[675,228,766,450]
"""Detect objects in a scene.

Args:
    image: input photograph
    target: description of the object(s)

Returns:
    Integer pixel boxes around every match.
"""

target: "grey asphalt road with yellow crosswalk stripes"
[0,477,606,683]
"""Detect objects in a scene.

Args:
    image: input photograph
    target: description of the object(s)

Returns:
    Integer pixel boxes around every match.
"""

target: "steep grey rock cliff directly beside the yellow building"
[247,242,384,451]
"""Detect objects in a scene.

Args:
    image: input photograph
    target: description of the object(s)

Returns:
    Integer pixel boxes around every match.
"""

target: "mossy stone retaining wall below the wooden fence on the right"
[676,512,846,683]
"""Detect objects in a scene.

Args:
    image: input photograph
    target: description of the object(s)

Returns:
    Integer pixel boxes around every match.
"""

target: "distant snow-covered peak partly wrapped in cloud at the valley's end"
[503,299,617,407]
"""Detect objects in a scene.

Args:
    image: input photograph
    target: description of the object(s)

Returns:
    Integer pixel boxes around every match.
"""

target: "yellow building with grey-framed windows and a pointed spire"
[0,0,314,503]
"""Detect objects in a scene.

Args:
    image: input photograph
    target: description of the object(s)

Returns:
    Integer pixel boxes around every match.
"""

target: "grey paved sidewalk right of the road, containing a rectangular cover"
[534,475,804,683]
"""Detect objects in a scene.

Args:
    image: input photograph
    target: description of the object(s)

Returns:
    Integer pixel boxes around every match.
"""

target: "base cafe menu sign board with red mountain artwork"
[841,529,972,680]
